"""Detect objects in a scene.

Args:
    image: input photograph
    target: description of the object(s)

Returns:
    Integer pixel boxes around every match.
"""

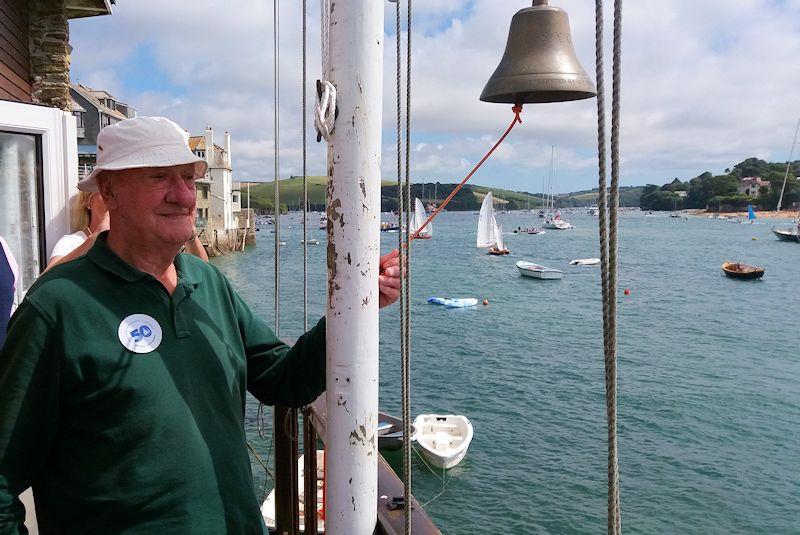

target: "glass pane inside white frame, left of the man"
[0,131,46,301]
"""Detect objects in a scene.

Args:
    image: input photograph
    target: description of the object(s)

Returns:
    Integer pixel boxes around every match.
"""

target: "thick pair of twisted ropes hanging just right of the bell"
[595,0,622,535]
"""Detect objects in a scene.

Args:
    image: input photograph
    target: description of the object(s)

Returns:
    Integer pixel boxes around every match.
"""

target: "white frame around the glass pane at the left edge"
[0,101,78,262]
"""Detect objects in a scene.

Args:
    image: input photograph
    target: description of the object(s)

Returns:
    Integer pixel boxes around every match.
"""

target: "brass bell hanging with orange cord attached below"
[481,0,597,104]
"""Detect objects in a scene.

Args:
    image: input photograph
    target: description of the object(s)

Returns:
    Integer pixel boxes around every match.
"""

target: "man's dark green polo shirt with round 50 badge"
[0,235,325,535]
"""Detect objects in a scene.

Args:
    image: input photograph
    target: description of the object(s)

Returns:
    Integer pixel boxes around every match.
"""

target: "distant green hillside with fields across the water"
[243,176,641,213]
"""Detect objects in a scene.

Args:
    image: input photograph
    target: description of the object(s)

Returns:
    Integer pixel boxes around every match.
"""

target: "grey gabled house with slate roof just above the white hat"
[70,84,136,178]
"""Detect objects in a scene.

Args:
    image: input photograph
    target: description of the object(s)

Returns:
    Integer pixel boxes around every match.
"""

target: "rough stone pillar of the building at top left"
[28,0,71,111]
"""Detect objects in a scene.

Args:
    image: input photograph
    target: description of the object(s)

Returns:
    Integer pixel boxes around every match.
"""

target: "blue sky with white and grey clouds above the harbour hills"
[70,0,800,192]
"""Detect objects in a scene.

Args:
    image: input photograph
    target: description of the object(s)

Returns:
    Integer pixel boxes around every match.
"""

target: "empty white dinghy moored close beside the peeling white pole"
[414,414,473,469]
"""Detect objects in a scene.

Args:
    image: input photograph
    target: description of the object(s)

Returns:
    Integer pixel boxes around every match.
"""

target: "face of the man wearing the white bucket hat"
[100,164,195,246]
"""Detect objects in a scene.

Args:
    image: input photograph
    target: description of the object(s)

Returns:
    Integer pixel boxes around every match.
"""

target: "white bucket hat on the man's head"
[78,117,208,191]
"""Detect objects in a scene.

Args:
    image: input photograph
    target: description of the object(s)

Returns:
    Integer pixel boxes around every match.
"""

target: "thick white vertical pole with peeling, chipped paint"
[325,0,384,535]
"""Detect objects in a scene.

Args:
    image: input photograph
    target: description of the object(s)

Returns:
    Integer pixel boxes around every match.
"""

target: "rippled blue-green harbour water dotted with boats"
[214,212,800,534]
